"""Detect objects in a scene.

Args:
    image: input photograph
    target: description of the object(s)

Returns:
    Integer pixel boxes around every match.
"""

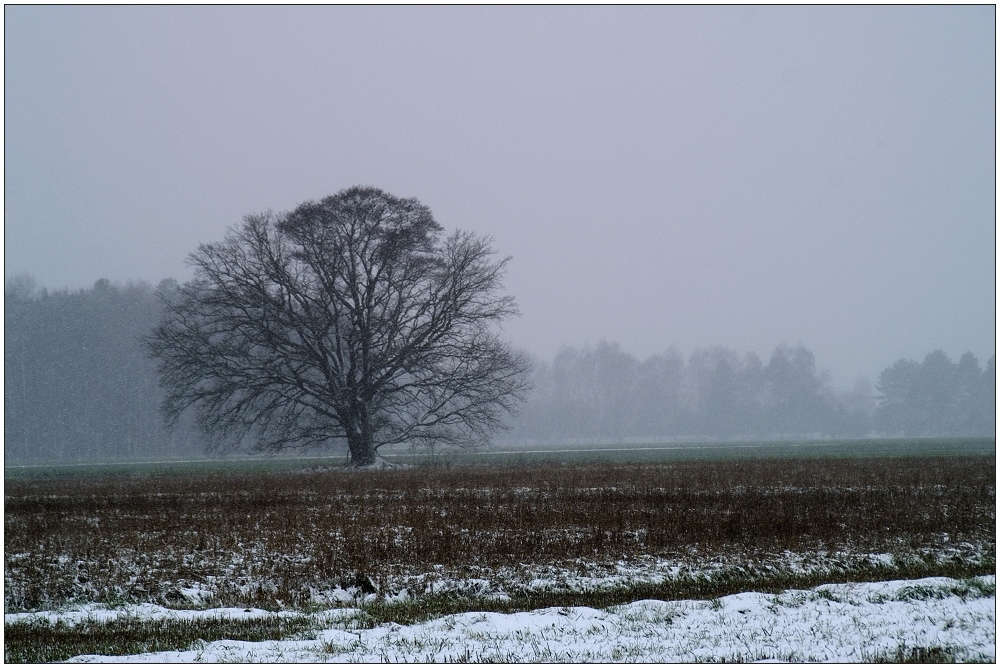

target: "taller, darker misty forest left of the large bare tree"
[4,275,203,461]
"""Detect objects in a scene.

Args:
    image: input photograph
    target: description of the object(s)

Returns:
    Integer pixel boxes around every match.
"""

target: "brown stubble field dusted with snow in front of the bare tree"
[4,457,996,612]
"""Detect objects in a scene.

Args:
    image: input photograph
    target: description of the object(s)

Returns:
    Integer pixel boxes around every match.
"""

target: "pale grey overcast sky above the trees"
[4,6,996,385]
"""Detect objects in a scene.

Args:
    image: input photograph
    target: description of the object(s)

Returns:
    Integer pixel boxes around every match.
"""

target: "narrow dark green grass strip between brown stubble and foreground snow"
[4,561,996,663]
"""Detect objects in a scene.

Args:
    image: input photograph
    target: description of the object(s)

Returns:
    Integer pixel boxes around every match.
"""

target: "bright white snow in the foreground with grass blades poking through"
[11,575,996,663]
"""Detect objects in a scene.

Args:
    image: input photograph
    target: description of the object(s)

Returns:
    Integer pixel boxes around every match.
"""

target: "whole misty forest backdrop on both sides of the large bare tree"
[4,276,996,462]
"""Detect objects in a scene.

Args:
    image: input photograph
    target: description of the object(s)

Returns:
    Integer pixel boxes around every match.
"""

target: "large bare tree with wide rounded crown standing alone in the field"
[148,187,528,466]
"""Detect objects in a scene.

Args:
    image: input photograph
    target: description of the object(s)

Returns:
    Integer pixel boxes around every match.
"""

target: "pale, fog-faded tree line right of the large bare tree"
[508,342,996,442]
